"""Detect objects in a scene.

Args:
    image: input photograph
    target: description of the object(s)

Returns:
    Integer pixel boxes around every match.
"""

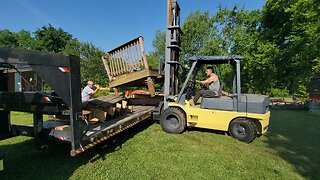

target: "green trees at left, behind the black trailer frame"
[0,24,108,86]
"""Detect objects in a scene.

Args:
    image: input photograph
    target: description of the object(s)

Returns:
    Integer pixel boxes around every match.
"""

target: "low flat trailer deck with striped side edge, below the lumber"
[43,106,155,156]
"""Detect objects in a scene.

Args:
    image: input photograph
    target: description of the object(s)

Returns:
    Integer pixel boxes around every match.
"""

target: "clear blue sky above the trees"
[0,0,266,52]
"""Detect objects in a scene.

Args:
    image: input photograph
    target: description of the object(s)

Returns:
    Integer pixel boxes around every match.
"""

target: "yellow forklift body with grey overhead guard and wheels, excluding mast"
[160,56,270,143]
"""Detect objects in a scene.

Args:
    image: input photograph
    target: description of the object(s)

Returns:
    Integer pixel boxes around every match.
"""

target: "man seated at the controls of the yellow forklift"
[189,66,220,106]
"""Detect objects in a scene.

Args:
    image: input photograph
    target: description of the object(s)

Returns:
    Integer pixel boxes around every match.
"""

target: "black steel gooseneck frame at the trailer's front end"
[0,48,83,153]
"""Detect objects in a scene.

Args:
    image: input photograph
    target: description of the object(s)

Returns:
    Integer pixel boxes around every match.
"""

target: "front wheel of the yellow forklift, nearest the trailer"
[160,107,186,134]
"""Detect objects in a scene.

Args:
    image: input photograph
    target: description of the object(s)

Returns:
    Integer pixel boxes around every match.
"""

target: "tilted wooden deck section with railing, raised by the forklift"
[102,36,159,95]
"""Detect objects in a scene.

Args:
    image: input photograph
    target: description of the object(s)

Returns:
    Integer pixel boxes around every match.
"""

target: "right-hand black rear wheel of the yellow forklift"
[229,119,257,143]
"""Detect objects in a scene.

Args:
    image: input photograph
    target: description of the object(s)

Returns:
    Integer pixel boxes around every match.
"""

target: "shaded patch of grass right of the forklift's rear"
[267,110,320,179]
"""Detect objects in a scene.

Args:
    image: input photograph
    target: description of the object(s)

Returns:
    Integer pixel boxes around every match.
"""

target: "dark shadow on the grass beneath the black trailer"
[0,120,154,180]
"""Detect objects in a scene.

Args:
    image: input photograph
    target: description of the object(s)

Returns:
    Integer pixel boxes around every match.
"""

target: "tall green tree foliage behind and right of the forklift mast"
[151,0,320,96]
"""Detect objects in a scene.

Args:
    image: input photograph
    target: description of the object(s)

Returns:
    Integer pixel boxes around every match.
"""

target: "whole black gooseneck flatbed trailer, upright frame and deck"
[0,48,155,156]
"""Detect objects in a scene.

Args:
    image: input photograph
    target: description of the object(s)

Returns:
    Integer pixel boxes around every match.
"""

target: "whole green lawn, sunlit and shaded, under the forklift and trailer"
[0,110,320,179]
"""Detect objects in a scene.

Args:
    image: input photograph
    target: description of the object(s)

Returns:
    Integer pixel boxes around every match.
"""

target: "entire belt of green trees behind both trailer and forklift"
[0,0,320,97]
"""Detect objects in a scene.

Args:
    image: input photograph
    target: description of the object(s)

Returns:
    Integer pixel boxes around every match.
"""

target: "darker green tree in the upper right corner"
[262,0,320,95]
